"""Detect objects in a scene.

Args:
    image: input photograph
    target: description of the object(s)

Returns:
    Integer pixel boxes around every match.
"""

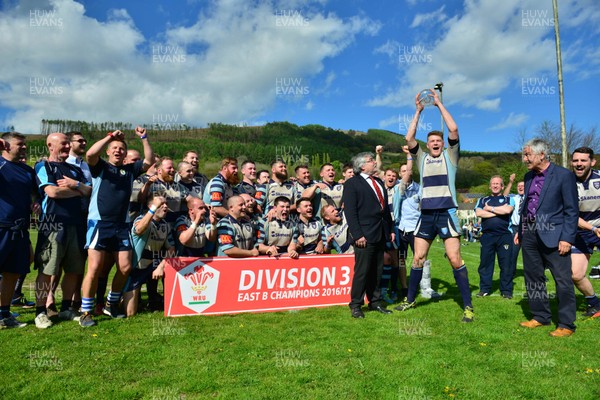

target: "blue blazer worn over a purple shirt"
[519,163,579,248]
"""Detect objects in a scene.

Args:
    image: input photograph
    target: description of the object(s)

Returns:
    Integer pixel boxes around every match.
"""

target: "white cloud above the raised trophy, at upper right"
[368,0,556,110]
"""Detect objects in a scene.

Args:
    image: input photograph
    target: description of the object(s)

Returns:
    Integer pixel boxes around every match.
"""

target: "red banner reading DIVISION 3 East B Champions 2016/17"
[165,254,354,317]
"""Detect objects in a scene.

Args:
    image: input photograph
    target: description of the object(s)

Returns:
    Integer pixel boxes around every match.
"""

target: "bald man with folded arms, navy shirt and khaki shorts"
[34,133,92,329]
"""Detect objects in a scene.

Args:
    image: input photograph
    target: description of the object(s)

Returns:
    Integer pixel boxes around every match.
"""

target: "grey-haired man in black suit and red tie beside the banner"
[342,153,394,318]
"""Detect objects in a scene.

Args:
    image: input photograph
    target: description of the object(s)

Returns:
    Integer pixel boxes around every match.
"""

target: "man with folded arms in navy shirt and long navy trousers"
[475,175,514,299]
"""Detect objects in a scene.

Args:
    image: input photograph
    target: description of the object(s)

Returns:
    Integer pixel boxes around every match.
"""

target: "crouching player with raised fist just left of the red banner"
[123,196,176,317]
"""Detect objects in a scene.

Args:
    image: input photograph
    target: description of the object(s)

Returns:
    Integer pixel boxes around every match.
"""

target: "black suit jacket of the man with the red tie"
[342,174,393,243]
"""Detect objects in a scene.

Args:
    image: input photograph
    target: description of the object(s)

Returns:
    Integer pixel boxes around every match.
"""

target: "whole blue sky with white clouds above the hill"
[0,0,600,152]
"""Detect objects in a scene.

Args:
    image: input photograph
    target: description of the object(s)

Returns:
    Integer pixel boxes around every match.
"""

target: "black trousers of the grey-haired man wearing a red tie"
[349,241,385,308]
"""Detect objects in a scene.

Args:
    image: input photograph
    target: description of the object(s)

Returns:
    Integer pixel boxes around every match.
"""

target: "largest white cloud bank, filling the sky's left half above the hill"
[0,0,380,133]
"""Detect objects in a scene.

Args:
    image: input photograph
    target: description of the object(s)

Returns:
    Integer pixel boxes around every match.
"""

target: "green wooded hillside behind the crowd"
[22,122,525,192]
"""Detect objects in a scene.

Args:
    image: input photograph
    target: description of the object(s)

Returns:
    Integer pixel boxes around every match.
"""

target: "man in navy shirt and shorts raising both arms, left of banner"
[79,126,156,327]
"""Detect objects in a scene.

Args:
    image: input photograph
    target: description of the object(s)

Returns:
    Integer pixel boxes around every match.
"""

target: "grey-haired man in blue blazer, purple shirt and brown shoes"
[515,139,579,337]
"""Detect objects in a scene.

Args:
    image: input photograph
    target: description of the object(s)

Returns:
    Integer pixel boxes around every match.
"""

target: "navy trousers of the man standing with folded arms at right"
[478,232,515,293]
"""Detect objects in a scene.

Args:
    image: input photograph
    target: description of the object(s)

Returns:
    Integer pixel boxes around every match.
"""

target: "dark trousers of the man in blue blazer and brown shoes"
[521,230,576,330]
